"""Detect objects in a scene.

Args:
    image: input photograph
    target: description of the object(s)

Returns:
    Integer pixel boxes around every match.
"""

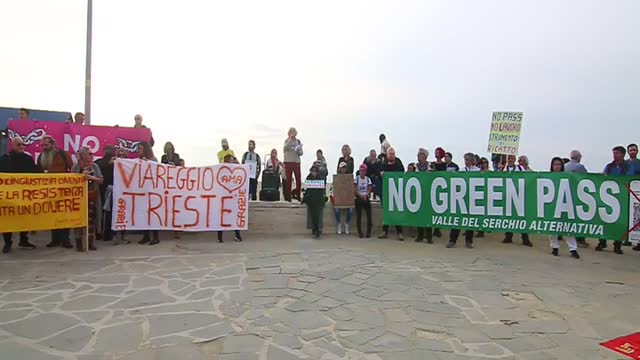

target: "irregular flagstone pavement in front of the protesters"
[0,235,640,360]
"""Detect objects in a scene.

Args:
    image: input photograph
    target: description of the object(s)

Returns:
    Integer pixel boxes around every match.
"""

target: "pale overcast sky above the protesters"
[0,0,640,173]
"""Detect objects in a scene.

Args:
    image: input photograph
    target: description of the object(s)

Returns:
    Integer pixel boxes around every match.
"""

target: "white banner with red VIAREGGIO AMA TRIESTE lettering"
[111,159,249,231]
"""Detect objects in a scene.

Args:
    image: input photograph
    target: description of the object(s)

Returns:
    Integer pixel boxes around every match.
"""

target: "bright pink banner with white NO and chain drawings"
[8,120,151,161]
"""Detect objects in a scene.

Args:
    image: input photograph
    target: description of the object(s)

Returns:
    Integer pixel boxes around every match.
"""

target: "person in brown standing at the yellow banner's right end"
[71,146,103,251]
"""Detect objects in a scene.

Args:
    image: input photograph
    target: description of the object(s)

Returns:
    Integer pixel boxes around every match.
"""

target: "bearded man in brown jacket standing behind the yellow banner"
[37,135,73,249]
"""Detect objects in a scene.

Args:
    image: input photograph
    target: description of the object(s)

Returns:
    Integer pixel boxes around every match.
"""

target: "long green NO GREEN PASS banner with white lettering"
[382,172,640,240]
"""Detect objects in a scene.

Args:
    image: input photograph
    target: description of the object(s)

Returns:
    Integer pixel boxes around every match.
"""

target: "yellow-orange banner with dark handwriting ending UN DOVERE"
[0,173,87,232]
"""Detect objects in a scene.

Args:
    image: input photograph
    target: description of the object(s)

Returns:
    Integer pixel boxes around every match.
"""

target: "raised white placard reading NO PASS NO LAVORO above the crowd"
[487,112,523,155]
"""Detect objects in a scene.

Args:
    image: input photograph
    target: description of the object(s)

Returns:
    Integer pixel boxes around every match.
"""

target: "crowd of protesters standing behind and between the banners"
[0,109,640,258]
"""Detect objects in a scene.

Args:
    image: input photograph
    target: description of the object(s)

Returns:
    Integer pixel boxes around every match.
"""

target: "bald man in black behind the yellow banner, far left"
[0,136,38,254]
